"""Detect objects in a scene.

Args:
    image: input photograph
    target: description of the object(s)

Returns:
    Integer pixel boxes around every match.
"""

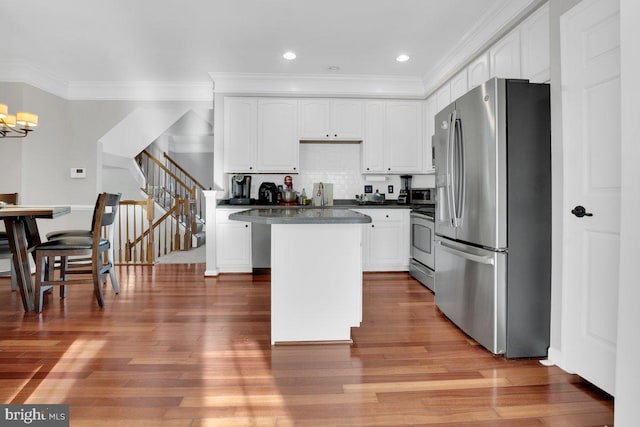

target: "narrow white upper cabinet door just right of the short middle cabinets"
[362,101,385,173]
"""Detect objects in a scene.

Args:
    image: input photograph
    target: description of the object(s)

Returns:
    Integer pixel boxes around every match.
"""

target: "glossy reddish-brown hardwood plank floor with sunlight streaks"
[0,264,613,427]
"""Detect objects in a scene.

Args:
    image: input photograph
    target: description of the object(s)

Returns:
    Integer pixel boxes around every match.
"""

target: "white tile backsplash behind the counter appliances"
[227,142,434,200]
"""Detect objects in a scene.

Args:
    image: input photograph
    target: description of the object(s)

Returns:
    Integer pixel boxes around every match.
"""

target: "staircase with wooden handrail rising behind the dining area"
[135,150,206,250]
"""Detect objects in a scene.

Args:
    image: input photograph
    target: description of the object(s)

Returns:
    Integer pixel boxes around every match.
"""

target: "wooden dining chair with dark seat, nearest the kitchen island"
[34,193,120,313]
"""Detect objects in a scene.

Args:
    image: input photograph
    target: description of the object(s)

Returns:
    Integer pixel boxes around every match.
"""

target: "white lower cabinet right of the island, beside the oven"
[354,208,409,271]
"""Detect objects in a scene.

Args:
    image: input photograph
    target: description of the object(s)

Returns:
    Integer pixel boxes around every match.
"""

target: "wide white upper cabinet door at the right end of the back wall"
[385,101,423,173]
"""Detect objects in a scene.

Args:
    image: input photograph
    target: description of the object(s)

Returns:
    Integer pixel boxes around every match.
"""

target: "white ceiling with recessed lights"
[0,0,534,98]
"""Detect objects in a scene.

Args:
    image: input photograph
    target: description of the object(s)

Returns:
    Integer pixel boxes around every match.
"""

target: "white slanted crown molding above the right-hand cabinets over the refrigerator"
[423,0,548,96]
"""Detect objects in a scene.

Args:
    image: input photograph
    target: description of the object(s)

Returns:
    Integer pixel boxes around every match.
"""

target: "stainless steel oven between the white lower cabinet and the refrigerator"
[409,207,435,291]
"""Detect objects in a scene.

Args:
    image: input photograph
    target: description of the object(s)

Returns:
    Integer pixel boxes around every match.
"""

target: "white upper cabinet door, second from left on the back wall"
[257,98,299,173]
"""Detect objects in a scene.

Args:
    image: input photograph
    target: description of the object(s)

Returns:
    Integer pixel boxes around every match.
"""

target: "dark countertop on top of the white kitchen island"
[229,205,371,224]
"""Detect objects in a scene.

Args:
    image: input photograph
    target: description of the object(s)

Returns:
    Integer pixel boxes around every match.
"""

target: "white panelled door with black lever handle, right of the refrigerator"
[561,0,620,394]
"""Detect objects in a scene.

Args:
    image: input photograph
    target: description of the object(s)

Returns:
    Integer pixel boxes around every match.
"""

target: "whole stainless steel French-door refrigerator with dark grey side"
[434,78,551,357]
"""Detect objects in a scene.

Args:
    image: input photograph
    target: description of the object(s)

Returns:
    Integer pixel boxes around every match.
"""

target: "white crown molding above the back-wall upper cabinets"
[209,72,425,99]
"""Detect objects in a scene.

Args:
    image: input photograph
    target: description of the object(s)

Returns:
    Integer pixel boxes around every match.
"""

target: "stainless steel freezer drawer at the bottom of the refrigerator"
[435,237,507,354]
